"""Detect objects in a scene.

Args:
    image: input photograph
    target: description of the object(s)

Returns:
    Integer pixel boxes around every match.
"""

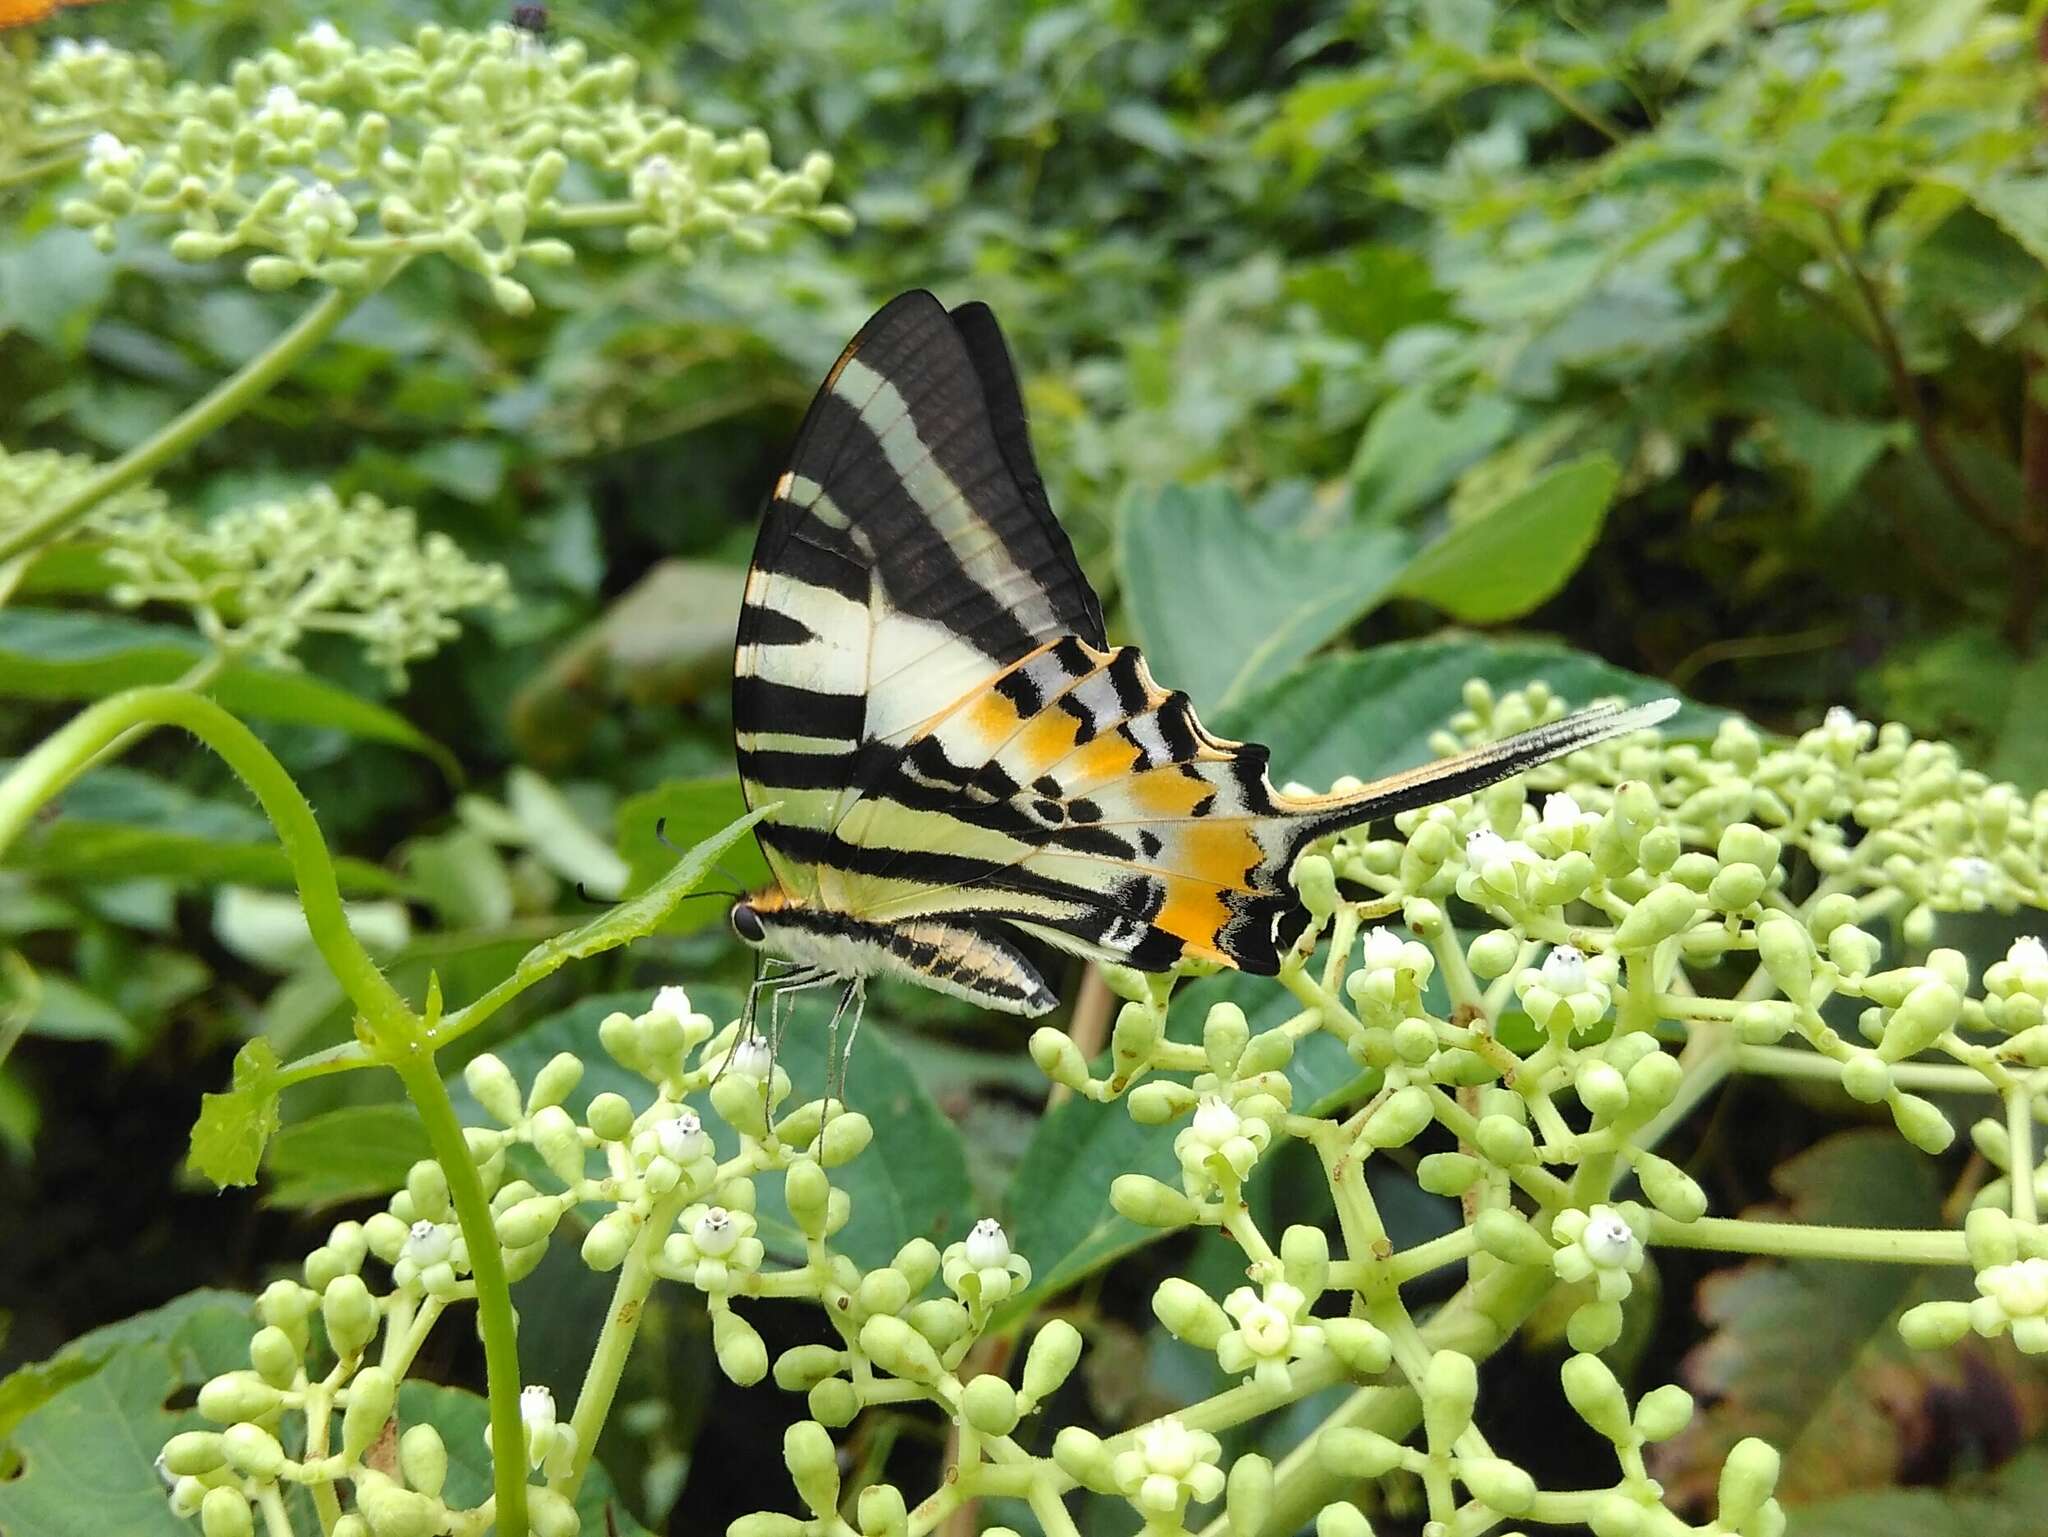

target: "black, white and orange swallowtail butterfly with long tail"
[729,291,1677,1029]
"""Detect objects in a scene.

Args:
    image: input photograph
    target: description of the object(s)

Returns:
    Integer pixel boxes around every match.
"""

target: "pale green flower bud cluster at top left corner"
[25,23,850,303]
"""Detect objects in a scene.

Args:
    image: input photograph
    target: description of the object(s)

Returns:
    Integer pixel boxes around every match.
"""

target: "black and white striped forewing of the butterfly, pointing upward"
[733,291,1104,910]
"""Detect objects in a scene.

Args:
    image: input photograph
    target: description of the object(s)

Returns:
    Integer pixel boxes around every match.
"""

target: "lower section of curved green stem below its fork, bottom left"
[391,1041,524,1537]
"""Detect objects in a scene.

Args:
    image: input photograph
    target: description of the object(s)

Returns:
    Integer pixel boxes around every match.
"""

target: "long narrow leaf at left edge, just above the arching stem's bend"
[0,609,459,777]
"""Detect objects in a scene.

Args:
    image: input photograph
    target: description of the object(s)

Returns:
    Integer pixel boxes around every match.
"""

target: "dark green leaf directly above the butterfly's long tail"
[1217,635,1726,785]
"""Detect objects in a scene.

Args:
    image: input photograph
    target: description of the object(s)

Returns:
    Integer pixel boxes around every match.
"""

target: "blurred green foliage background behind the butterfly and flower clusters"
[0,0,2048,1531]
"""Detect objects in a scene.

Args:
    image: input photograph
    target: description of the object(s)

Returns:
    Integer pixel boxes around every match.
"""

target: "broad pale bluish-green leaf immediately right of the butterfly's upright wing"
[1116,486,1411,711]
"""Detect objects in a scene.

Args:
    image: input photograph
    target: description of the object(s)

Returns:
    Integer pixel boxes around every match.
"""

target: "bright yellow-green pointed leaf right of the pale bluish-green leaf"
[1399,453,1620,625]
